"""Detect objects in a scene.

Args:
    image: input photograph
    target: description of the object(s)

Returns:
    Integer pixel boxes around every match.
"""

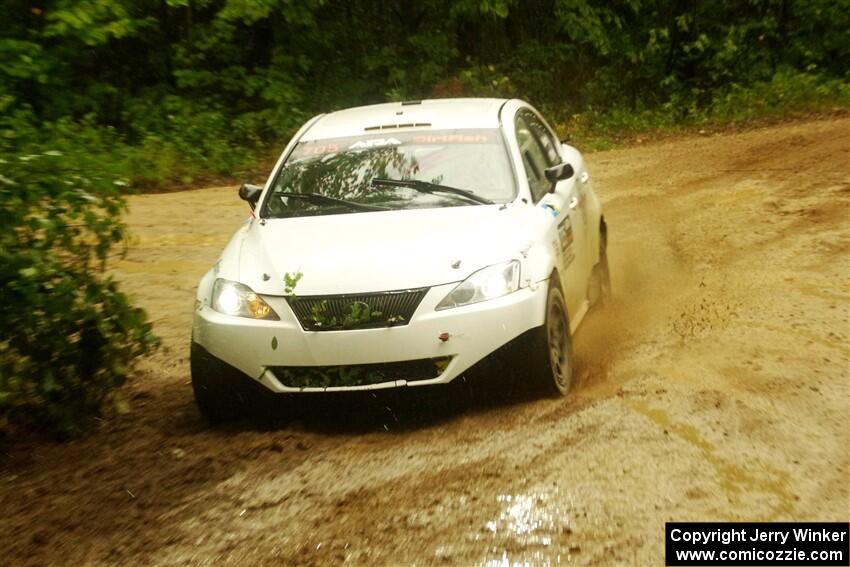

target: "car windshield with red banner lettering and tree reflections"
[261,129,516,218]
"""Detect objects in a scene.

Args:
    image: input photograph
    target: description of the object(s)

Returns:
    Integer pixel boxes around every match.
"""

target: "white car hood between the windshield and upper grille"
[238,204,534,295]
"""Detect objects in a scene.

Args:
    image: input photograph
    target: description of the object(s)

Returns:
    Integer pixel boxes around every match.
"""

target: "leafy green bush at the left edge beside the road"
[0,113,156,435]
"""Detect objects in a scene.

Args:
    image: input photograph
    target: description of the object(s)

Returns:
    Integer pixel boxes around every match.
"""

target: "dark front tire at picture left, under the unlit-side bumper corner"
[189,341,244,424]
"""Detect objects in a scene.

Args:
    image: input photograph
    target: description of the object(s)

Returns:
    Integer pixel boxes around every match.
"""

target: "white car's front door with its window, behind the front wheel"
[515,109,588,315]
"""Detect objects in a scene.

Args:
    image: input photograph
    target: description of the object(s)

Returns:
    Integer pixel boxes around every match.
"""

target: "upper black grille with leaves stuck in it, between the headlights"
[287,287,428,331]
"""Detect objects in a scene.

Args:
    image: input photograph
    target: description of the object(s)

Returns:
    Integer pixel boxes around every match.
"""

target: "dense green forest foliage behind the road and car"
[0,0,850,191]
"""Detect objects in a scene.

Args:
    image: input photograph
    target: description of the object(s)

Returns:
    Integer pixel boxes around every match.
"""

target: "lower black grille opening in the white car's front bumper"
[269,356,451,388]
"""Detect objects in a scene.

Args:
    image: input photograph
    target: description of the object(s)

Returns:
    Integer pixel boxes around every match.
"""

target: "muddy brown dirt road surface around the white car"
[0,117,850,565]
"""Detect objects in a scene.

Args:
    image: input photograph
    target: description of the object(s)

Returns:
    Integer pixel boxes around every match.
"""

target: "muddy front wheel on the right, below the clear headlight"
[528,284,574,396]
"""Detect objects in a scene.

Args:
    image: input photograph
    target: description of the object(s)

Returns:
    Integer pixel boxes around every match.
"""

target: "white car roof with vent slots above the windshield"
[301,98,507,141]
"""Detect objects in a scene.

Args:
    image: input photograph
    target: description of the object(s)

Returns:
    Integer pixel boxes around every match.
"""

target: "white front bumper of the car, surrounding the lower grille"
[192,284,547,392]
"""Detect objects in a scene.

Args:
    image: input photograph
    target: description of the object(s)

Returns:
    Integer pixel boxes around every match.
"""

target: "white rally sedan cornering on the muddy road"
[191,99,610,421]
